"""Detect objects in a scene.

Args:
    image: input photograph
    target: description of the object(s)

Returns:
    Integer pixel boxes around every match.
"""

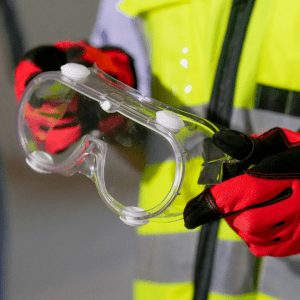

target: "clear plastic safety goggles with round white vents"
[17,64,228,226]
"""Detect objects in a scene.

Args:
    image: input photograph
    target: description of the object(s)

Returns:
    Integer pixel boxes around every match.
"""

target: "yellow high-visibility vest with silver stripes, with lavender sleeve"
[91,0,300,300]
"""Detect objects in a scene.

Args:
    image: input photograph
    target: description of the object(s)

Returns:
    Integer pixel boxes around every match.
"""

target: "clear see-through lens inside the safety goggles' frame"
[24,81,175,217]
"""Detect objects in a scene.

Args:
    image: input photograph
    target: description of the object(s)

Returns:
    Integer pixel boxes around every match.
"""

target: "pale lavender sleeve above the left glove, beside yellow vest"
[89,0,151,96]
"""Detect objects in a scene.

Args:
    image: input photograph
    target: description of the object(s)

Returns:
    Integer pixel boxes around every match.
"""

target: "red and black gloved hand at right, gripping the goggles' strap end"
[184,128,300,256]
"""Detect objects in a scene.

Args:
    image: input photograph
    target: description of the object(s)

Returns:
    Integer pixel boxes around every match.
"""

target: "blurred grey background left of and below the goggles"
[0,0,135,300]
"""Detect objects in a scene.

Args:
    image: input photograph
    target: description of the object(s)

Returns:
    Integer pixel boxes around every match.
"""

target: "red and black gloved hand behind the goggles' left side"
[15,41,137,154]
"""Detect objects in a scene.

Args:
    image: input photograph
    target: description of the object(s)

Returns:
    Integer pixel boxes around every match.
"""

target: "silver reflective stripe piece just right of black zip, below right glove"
[210,240,255,295]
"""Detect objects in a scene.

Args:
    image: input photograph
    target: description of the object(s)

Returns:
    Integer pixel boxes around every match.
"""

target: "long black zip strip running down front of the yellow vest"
[193,0,255,300]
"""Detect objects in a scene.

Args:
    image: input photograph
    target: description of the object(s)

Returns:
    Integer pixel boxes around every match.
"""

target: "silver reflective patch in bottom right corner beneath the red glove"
[259,254,300,300]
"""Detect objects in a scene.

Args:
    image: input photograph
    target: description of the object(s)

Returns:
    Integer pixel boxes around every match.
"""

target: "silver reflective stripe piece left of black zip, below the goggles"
[136,232,199,283]
